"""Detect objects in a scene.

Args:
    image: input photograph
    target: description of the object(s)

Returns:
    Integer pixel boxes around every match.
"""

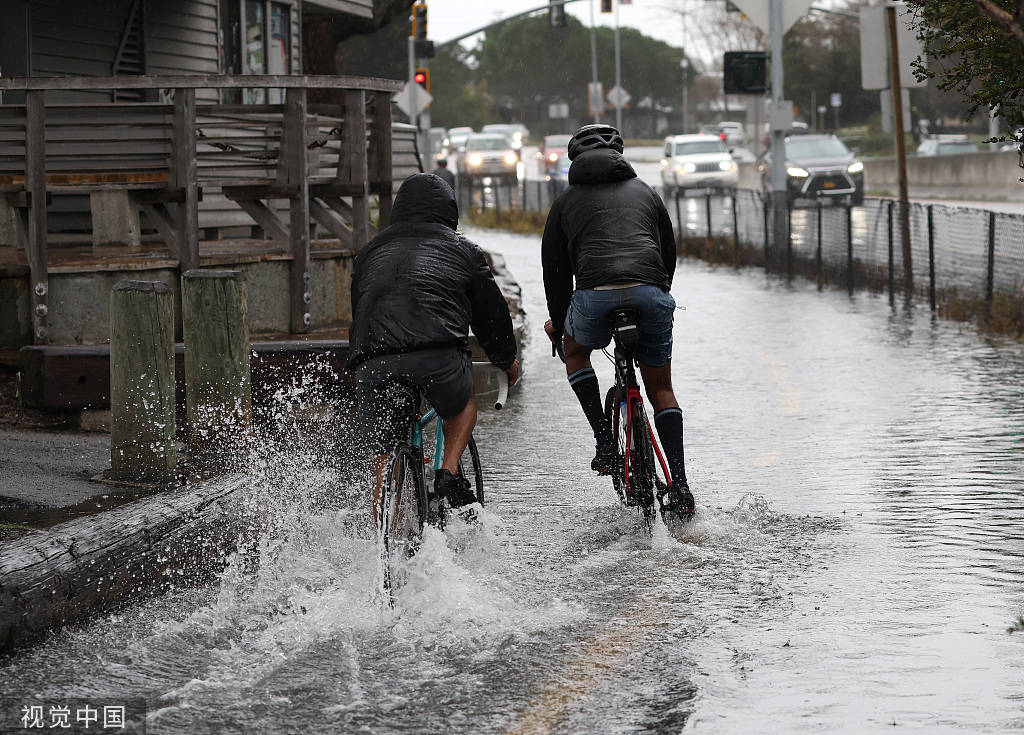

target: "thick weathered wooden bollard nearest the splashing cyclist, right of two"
[181,270,252,463]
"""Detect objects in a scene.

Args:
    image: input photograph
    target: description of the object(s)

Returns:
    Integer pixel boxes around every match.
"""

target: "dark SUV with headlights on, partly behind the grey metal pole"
[758,135,864,206]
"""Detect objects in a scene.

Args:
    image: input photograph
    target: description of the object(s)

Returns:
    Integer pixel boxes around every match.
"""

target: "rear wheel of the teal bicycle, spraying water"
[376,444,427,604]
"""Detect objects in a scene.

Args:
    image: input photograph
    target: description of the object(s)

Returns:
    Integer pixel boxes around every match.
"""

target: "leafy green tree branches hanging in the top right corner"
[909,0,1024,141]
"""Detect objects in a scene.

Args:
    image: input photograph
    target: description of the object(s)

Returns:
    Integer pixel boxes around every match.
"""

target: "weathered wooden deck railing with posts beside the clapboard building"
[0,75,400,344]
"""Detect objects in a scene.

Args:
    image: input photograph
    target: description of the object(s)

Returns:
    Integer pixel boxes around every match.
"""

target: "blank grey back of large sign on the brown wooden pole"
[860,3,926,89]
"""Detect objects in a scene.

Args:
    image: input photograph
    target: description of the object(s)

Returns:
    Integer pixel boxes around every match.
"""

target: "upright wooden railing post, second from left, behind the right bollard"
[169,88,199,272]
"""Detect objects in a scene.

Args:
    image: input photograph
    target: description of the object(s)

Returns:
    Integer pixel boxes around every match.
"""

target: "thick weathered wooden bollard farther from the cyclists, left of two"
[111,280,177,483]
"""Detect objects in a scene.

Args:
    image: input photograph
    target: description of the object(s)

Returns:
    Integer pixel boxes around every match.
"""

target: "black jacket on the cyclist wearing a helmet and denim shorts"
[541,148,676,332]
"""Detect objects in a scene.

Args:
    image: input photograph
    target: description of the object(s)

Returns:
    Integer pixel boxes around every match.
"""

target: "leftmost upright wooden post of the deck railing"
[25,89,50,345]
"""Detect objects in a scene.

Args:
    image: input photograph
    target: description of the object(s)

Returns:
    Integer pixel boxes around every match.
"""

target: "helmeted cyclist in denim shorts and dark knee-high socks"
[541,125,693,510]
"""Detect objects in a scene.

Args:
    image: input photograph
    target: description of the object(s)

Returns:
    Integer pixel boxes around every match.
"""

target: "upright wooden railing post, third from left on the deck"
[279,87,312,334]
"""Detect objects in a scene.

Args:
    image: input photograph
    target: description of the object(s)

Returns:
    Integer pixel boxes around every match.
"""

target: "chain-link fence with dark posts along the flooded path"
[667,189,1024,304]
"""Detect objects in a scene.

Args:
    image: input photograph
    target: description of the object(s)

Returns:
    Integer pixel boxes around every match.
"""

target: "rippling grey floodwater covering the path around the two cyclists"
[0,230,1024,735]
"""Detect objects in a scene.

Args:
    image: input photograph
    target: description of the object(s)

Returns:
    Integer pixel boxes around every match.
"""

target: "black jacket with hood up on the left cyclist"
[348,174,516,369]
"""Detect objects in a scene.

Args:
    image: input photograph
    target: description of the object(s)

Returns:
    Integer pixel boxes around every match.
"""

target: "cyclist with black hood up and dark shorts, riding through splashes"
[348,174,519,522]
